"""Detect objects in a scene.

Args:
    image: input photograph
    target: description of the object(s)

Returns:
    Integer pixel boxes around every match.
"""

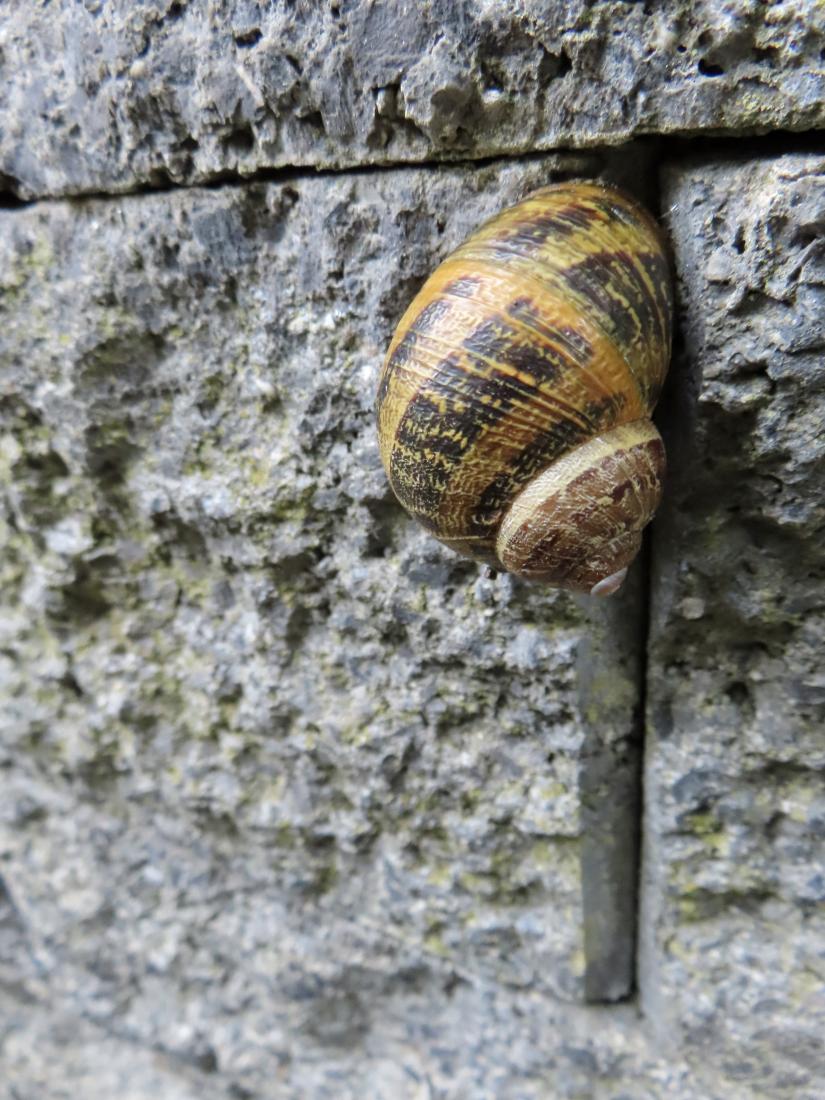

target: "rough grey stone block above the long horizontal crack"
[0,0,825,198]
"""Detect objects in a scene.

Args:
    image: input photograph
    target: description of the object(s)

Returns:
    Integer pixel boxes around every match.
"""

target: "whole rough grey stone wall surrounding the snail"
[0,0,825,1100]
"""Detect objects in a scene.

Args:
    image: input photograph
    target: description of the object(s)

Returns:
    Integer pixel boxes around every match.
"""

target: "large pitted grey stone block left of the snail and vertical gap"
[0,151,689,1098]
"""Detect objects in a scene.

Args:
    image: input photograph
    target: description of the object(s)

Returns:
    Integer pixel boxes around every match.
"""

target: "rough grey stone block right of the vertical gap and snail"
[642,155,825,1100]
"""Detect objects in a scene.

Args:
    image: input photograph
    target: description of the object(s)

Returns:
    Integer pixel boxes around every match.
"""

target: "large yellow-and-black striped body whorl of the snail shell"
[378,183,672,586]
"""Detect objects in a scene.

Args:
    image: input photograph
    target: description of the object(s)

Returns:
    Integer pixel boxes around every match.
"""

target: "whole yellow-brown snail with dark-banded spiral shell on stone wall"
[377,182,673,595]
